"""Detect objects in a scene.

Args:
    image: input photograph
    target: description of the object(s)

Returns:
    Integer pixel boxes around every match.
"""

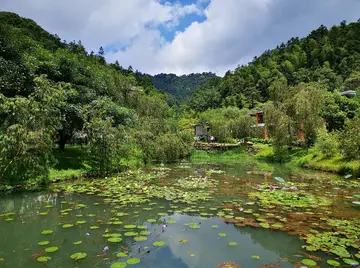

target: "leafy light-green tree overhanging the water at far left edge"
[0,77,67,184]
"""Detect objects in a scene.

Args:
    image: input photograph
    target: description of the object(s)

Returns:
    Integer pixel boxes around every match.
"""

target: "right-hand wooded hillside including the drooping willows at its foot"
[189,20,360,163]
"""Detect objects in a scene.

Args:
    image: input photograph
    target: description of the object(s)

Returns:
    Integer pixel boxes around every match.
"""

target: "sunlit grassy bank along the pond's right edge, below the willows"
[255,145,360,177]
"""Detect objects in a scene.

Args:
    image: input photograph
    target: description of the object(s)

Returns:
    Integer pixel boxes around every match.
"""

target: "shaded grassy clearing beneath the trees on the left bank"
[50,146,90,181]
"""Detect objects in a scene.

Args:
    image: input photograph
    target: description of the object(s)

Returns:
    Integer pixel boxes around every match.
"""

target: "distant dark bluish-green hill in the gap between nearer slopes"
[152,73,217,103]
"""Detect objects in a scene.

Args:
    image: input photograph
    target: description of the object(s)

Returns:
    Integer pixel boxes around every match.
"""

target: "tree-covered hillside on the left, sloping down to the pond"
[0,12,192,184]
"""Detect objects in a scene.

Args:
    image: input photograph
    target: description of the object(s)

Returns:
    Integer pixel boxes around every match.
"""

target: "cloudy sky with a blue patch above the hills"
[0,0,360,75]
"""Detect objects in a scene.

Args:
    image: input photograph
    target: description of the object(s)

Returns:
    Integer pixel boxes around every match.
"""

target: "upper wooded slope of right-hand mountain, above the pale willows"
[190,20,360,114]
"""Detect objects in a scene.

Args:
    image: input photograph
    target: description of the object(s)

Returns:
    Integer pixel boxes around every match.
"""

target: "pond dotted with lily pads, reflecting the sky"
[0,162,360,268]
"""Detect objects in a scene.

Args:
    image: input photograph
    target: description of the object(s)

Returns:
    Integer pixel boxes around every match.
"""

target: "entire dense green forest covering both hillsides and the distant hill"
[0,12,360,184]
